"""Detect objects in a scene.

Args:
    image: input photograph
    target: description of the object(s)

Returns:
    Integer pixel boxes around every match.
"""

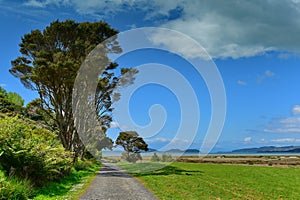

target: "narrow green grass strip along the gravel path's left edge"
[34,161,101,200]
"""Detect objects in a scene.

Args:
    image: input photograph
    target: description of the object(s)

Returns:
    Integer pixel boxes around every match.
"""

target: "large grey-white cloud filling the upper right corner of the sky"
[149,0,300,58]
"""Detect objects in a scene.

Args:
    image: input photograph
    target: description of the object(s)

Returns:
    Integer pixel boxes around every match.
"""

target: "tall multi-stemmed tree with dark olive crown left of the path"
[10,20,135,159]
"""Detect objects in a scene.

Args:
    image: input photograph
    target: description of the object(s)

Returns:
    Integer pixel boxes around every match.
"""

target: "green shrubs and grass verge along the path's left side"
[0,114,100,200]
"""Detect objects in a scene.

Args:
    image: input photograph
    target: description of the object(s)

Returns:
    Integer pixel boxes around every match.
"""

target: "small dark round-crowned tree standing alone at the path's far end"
[116,131,148,163]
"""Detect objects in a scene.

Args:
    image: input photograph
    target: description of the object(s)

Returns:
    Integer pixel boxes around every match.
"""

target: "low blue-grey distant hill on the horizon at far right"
[231,146,300,154]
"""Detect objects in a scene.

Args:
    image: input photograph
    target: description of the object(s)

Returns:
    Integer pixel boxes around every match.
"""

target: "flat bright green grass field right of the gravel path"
[120,162,300,200]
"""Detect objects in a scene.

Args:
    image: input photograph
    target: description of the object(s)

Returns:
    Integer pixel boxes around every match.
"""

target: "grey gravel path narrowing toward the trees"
[79,161,157,200]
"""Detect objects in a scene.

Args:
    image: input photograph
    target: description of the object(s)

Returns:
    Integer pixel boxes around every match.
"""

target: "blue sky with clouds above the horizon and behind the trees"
[0,0,300,151]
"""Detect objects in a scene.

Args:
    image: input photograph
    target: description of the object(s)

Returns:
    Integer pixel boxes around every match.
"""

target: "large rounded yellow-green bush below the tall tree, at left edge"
[0,116,73,186]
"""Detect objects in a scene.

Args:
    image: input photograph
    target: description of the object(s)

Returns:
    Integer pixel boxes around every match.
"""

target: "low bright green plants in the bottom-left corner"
[0,171,32,200]
